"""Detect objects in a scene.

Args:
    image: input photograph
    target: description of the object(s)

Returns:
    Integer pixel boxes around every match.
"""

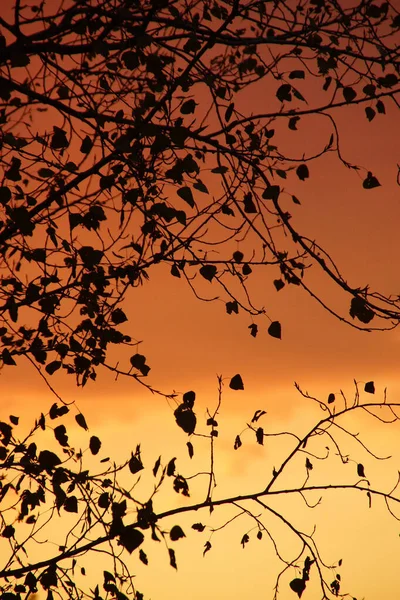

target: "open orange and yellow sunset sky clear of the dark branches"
[0,0,400,600]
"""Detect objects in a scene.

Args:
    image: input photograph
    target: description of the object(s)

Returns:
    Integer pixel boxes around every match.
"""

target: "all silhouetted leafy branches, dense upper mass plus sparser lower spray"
[0,0,400,600]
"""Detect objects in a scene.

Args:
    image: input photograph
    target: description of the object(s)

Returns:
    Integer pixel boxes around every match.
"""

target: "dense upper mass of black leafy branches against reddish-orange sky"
[0,0,400,384]
